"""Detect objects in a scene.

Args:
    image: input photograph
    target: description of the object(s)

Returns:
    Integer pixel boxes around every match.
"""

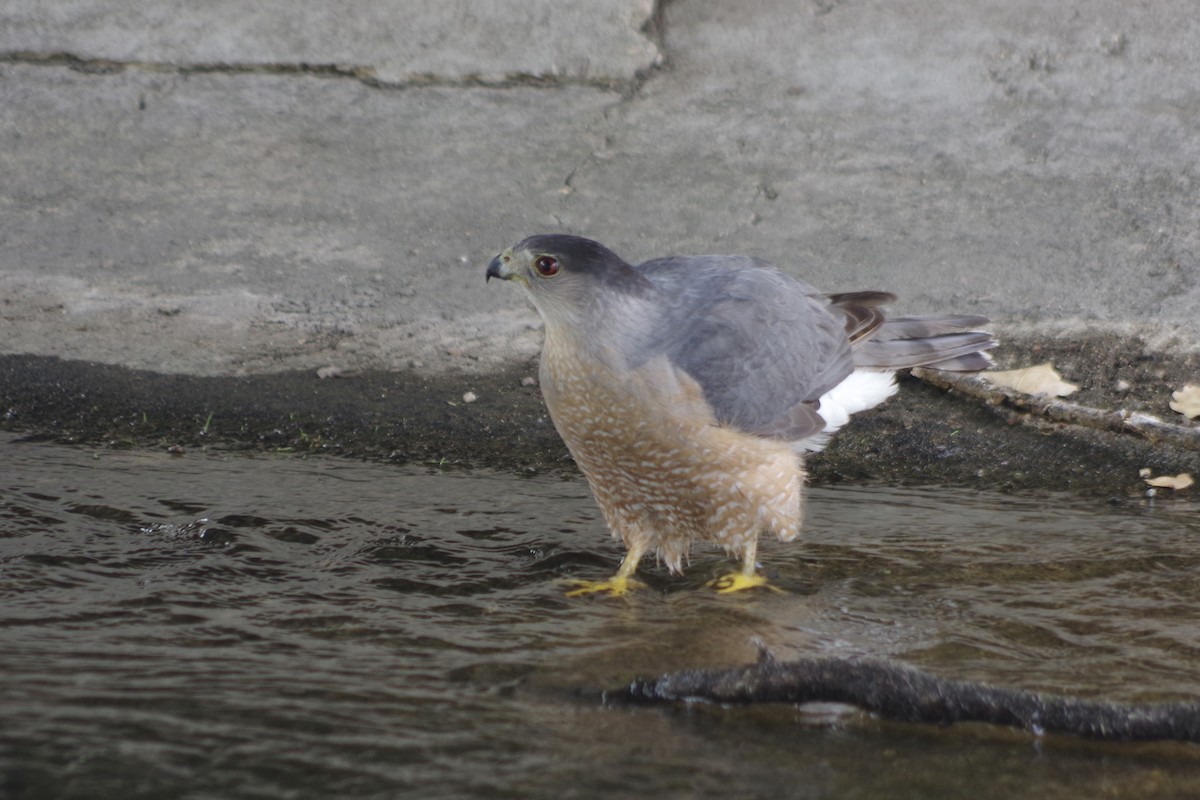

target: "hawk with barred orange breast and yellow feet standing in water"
[487,234,996,595]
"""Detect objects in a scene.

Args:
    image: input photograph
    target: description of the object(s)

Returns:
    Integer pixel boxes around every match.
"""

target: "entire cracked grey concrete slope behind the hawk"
[0,0,1200,474]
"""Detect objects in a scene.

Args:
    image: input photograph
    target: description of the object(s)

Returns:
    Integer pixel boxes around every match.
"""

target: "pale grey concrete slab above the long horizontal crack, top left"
[0,0,659,84]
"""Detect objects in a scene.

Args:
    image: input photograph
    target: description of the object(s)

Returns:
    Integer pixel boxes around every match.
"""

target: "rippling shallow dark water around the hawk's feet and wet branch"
[0,437,1200,799]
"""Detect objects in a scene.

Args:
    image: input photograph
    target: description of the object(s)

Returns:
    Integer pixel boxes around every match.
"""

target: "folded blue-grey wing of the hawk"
[635,255,853,440]
